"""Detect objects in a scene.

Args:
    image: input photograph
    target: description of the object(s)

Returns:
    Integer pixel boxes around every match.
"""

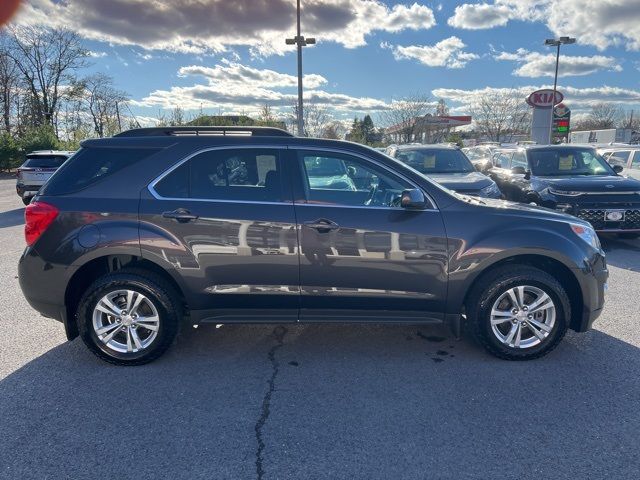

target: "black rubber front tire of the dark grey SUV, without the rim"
[465,265,571,360]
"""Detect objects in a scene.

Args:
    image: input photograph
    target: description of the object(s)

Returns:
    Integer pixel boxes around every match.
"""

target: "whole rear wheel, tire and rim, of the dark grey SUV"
[77,269,182,365]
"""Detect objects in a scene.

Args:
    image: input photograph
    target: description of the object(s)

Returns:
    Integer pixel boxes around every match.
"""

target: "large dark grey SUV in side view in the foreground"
[18,127,608,365]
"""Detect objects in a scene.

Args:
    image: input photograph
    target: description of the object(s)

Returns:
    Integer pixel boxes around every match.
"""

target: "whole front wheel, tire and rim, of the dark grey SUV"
[467,265,571,360]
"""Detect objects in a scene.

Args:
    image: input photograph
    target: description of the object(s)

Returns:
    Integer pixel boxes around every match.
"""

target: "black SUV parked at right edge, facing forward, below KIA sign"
[490,145,640,237]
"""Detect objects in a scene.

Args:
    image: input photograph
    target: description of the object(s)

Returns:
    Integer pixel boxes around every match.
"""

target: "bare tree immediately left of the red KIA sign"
[471,90,531,142]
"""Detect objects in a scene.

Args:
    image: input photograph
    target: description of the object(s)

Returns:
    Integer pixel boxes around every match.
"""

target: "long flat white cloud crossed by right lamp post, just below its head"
[494,48,622,78]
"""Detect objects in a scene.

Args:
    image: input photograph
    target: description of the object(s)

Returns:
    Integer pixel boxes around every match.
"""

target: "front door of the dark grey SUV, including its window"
[291,150,447,321]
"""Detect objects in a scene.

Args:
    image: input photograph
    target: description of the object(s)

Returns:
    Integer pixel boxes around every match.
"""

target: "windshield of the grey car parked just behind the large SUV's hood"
[396,148,475,175]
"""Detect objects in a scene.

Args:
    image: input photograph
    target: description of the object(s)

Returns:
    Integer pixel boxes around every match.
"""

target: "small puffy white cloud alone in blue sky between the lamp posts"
[382,37,479,68]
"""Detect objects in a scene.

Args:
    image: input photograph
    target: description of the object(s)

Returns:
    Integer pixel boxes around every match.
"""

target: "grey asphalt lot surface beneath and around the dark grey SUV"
[0,177,640,479]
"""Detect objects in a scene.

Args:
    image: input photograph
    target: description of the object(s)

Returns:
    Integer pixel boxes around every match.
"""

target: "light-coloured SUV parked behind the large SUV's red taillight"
[16,150,74,205]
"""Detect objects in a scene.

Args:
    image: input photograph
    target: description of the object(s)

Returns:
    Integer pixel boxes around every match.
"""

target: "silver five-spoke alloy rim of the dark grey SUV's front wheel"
[491,285,556,349]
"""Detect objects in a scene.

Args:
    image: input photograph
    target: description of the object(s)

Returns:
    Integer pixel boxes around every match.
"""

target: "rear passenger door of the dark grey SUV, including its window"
[140,147,299,322]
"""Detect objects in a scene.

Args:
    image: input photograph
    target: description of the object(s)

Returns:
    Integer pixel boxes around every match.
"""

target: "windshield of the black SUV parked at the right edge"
[528,148,615,177]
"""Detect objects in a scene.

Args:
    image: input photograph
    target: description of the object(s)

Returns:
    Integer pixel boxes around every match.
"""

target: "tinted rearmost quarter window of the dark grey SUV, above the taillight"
[41,147,160,195]
